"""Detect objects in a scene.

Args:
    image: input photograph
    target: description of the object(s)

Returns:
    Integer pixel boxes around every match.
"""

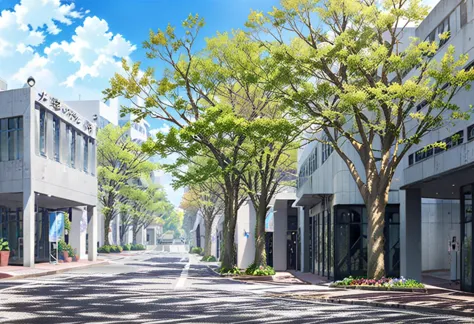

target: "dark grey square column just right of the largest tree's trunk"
[400,189,422,281]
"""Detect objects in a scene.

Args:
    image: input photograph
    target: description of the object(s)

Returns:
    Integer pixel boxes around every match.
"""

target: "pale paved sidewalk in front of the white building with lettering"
[0,260,108,279]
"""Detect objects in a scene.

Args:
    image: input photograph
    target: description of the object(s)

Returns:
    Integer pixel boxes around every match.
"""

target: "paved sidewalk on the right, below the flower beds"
[271,272,474,322]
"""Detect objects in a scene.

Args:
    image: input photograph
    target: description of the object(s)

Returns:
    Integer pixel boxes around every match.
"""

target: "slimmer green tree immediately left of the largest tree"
[242,119,298,267]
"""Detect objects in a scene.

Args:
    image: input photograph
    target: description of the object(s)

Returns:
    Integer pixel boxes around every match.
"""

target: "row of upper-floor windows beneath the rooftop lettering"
[38,108,95,175]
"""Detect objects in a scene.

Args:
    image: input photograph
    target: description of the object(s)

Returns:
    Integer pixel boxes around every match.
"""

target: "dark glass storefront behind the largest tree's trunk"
[309,205,400,280]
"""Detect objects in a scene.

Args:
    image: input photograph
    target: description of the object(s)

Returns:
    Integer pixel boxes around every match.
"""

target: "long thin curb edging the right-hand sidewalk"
[272,294,474,319]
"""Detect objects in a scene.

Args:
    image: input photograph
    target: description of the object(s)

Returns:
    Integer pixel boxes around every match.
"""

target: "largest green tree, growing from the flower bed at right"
[247,0,474,278]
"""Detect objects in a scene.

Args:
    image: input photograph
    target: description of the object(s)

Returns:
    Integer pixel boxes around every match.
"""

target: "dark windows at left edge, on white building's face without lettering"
[0,117,23,161]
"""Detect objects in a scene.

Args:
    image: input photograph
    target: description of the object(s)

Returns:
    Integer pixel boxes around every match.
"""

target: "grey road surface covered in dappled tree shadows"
[0,263,468,323]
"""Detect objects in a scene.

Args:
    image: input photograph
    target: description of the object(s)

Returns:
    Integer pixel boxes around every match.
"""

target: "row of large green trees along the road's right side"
[104,0,474,278]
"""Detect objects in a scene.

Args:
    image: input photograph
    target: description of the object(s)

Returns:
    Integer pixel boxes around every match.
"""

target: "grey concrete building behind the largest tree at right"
[295,0,474,291]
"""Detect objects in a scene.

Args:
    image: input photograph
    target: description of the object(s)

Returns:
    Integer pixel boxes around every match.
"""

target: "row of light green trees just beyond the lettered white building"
[97,124,174,245]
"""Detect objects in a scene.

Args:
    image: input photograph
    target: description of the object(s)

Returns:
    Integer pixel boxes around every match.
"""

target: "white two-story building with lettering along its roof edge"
[0,79,97,267]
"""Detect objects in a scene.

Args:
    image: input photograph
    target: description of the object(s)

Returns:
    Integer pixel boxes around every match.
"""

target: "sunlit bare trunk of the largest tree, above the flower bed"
[367,194,388,279]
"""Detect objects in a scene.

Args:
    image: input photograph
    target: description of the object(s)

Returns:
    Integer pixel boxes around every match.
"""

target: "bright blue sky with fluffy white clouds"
[0,0,438,205]
